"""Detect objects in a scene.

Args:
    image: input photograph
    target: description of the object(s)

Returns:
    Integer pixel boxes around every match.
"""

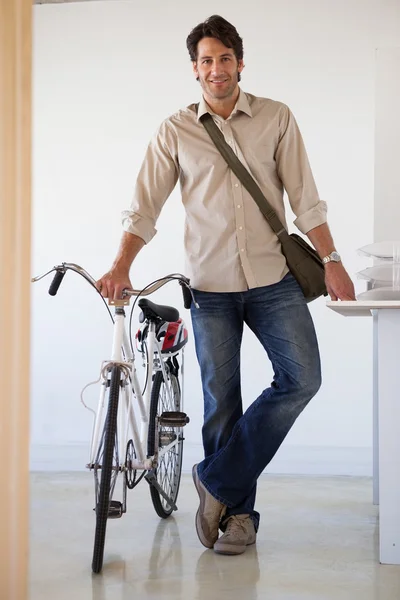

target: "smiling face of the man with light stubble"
[193,38,244,100]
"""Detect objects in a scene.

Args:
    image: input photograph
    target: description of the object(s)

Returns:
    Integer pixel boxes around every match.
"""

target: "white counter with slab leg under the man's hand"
[327,300,400,565]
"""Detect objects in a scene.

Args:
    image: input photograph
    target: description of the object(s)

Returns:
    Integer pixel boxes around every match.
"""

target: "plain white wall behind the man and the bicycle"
[32,0,400,474]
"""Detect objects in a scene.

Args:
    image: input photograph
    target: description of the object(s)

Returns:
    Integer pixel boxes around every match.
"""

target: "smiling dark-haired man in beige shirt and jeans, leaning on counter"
[98,16,354,554]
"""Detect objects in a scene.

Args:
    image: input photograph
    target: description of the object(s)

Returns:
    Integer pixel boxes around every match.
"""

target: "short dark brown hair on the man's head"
[186,15,243,62]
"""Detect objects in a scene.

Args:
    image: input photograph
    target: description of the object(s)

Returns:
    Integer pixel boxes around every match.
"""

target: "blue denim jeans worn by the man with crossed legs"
[191,273,321,529]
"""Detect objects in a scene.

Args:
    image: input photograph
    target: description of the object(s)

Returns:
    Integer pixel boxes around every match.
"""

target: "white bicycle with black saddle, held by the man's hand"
[32,263,198,573]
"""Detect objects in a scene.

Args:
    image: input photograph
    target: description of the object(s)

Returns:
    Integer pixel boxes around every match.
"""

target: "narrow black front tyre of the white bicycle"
[92,367,121,573]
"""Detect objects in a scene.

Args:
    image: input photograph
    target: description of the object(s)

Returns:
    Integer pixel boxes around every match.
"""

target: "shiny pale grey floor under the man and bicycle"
[30,473,400,600]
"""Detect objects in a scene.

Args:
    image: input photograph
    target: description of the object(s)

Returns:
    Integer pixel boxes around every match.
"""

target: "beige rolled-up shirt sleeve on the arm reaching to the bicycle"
[122,121,179,244]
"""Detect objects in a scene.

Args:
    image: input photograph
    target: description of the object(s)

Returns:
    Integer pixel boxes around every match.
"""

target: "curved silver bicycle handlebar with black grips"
[31,263,197,308]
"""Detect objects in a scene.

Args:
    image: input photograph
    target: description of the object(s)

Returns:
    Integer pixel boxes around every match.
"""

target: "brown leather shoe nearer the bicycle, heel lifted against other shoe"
[192,465,226,548]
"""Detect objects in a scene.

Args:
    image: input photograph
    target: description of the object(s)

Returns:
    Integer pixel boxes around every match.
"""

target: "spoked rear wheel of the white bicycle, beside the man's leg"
[148,371,183,519]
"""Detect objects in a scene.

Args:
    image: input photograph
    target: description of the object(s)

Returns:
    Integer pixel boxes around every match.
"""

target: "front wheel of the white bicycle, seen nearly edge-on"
[92,367,121,573]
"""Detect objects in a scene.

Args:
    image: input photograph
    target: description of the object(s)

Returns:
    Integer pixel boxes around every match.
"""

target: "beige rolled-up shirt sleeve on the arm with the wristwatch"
[275,104,327,234]
